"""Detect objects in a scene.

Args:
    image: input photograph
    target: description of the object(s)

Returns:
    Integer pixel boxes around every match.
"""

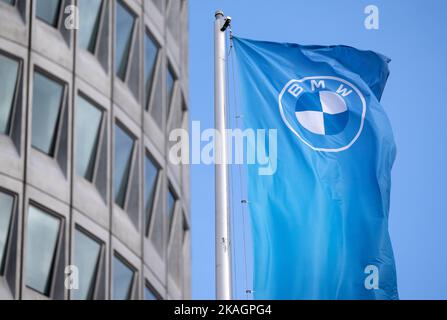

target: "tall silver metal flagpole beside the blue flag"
[214,11,232,300]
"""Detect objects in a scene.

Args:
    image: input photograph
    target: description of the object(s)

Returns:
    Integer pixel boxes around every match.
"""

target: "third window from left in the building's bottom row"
[71,229,102,300]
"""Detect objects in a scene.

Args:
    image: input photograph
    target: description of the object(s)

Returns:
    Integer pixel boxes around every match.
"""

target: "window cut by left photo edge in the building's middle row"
[0,54,19,134]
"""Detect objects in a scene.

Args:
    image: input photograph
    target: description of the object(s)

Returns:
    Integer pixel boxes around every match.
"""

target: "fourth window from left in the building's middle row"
[115,124,135,209]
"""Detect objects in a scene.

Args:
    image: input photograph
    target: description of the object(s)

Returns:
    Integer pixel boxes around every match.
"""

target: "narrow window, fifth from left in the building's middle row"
[144,154,159,234]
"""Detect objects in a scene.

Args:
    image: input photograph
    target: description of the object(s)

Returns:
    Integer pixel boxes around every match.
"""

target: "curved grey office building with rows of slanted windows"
[0,0,190,299]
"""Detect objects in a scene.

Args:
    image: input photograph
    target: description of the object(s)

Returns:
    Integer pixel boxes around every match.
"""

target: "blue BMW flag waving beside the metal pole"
[233,37,398,300]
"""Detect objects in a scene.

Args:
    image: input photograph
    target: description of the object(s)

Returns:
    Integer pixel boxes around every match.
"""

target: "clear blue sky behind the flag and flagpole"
[189,0,447,299]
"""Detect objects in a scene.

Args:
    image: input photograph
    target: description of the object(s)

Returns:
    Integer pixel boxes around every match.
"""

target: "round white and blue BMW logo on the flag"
[279,76,366,152]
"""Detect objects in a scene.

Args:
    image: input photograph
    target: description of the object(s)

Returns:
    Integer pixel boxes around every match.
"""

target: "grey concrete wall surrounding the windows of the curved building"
[0,0,191,299]
